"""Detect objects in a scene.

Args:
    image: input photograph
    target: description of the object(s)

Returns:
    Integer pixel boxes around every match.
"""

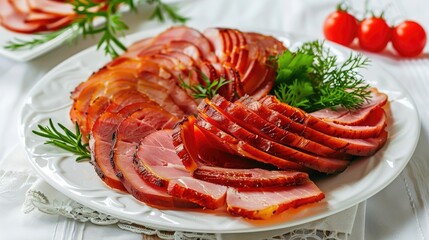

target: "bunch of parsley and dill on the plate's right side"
[272,41,371,112]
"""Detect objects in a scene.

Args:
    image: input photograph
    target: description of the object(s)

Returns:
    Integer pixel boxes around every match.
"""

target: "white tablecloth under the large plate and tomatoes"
[0,0,429,240]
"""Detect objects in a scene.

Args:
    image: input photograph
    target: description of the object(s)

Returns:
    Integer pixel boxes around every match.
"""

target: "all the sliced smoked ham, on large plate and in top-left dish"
[65,26,388,219]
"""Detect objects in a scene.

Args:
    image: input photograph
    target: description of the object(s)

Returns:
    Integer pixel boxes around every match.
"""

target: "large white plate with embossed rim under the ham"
[20,29,420,233]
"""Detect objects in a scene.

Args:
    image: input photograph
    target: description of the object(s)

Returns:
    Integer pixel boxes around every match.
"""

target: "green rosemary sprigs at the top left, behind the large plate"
[4,0,188,57]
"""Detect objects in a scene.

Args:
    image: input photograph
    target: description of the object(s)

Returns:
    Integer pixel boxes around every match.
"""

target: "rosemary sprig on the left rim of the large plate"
[32,119,91,162]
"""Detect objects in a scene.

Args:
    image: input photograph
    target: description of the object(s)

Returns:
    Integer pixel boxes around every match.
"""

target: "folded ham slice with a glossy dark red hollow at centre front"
[173,116,308,188]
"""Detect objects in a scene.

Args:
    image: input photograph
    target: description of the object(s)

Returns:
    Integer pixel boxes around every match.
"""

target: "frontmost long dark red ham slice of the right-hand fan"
[198,99,350,174]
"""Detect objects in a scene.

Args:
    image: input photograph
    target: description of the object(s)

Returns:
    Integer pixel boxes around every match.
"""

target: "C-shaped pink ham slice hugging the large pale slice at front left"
[111,106,186,207]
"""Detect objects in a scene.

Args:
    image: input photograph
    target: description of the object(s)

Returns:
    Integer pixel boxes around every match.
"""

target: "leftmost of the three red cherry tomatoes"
[323,10,358,46]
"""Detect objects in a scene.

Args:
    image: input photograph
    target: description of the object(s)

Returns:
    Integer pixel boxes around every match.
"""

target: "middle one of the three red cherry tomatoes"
[358,17,391,52]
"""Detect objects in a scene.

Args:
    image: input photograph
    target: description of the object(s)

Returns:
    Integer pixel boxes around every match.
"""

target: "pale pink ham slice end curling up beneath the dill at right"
[310,88,387,125]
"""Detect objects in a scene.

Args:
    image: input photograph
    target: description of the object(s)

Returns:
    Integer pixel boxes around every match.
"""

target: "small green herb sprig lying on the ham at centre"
[180,72,232,99]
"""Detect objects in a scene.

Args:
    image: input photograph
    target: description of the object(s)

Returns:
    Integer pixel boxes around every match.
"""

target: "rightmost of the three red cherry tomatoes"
[392,21,426,57]
